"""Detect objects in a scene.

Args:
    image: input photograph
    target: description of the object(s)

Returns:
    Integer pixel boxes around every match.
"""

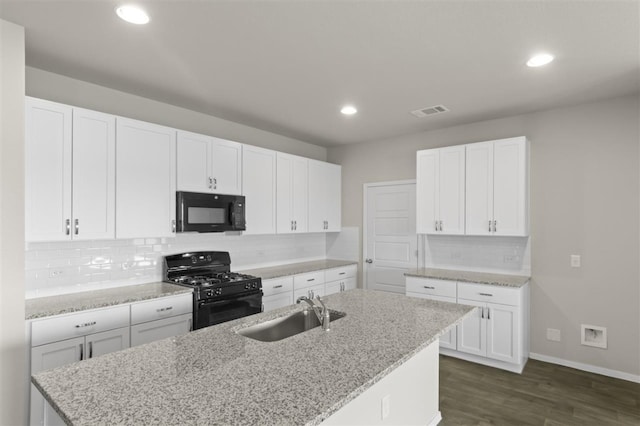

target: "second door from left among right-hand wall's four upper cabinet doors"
[438,146,465,235]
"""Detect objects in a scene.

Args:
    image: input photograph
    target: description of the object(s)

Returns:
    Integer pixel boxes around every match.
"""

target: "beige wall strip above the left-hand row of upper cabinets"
[26,67,327,160]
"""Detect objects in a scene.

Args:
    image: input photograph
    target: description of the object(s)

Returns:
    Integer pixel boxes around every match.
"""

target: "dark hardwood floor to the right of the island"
[440,355,640,426]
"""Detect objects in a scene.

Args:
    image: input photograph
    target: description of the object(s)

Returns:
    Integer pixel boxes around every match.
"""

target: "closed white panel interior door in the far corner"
[364,183,418,294]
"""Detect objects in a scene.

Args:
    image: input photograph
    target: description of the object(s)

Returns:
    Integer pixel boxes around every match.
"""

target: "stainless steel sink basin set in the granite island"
[238,310,347,342]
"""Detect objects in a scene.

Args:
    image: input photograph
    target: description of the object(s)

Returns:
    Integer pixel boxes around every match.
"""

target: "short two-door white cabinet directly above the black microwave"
[177,131,242,195]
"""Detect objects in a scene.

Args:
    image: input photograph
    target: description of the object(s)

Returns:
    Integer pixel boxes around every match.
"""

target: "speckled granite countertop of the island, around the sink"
[32,289,475,425]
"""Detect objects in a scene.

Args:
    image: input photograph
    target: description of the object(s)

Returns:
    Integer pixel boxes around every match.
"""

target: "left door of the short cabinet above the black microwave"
[176,131,213,192]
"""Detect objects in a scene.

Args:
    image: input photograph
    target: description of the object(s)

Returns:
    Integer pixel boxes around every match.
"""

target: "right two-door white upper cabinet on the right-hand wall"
[466,137,529,236]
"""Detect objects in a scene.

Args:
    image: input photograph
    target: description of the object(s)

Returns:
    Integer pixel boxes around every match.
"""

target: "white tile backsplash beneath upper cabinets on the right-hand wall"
[418,235,531,275]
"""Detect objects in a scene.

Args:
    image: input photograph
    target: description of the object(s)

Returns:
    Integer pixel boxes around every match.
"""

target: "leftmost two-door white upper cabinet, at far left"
[25,98,115,241]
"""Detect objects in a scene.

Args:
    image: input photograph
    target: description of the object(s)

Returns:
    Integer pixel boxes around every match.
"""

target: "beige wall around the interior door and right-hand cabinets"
[328,95,640,375]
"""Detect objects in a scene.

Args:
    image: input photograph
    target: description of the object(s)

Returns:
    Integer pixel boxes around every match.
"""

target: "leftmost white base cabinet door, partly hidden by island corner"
[29,337,84,425]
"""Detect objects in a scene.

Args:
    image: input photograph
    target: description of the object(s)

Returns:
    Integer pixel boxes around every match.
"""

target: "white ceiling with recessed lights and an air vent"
[0,0,640,146]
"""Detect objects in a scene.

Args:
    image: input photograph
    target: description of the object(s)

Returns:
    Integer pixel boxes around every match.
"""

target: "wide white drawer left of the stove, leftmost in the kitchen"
[31,305,129,346]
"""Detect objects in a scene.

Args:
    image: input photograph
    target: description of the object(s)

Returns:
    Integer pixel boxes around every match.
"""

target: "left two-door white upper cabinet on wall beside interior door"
[416,146,465,234]
